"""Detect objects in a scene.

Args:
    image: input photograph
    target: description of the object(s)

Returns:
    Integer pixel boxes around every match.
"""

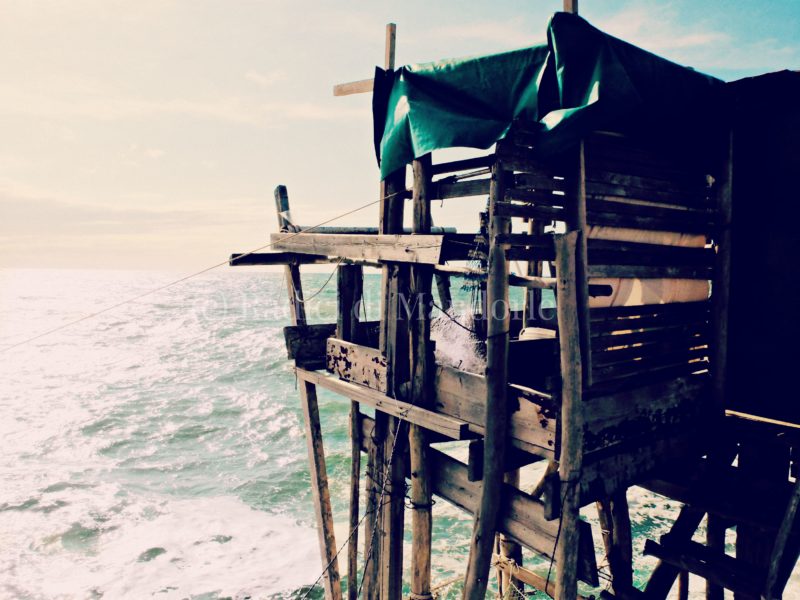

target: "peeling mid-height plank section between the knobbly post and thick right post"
[435,366,557,457]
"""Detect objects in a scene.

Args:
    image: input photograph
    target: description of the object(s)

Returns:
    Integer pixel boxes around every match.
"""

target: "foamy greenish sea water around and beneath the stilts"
[0,269,797,599]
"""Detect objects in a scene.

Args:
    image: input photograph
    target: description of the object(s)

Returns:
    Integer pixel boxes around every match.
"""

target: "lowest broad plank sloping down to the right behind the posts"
[431,448,597,585]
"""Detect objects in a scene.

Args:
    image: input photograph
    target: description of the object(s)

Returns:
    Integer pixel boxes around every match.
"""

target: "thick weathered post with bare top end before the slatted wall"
[555,231,583,600]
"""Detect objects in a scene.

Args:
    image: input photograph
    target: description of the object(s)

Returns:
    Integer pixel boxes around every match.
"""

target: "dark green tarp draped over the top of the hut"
[373,13,723,177]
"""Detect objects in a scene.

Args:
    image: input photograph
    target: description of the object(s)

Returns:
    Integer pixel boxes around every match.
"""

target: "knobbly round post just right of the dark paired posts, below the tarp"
[408,154,434,600]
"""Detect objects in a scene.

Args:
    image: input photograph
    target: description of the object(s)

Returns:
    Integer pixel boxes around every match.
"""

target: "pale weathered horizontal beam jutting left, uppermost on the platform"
[271,233,444,265]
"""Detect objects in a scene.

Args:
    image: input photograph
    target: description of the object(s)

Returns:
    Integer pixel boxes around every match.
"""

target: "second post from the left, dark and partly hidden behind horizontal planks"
[336,265,364,600]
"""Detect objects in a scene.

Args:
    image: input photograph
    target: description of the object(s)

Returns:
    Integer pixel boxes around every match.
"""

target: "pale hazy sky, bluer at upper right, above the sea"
[0,0,800,270]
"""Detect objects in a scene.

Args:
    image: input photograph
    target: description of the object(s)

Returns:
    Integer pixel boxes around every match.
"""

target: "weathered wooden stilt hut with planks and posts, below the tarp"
[231,9,800,600]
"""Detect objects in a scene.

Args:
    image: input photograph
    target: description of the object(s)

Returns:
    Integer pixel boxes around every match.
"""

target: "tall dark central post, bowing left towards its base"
[464,162,511,600]
